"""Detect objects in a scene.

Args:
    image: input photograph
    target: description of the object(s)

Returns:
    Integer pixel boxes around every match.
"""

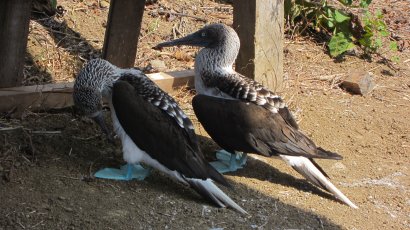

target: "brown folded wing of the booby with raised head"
[193,95,341,159]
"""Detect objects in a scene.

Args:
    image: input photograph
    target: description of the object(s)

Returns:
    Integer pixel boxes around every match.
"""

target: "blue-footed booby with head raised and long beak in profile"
[155,24,357,208]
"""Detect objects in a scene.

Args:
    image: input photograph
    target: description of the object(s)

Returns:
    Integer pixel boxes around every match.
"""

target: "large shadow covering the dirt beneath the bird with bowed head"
[0,113,341,229]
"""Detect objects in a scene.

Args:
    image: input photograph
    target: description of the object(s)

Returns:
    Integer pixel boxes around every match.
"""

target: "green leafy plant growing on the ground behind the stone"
[285,0,397,57]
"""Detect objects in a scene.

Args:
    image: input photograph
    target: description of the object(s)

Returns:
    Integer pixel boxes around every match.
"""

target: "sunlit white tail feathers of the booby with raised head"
[279,155,358,209]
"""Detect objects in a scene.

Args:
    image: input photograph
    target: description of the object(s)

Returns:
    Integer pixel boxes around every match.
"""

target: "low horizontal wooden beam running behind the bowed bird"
[0,70,194,117]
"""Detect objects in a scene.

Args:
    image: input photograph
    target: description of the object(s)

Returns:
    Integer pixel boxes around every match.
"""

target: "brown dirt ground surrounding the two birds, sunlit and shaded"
[0,0,410,229]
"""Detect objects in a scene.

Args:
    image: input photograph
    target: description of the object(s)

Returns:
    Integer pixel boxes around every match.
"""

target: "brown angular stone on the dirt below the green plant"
[340,71,376,95]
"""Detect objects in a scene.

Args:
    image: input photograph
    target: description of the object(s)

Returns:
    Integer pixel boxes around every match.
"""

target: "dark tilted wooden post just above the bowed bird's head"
[103,0,145,68]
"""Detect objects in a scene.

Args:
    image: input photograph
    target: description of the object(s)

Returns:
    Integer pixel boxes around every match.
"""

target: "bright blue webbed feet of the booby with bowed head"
[94,164,151,180]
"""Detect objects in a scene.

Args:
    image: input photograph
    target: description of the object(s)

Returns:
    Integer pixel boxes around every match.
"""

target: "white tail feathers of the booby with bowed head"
[185,178,247,214]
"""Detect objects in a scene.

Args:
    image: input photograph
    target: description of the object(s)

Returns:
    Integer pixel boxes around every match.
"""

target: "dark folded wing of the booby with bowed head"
[112,76,228,185]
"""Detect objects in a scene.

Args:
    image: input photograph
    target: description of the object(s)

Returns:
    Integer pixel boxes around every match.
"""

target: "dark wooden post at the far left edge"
[0,0,31,88]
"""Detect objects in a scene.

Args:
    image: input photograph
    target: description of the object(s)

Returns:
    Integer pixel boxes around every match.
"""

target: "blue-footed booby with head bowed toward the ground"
[73,59,246,214]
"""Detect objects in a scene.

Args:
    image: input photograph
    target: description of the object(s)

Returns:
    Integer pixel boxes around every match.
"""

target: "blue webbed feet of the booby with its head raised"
[210,150,247,173]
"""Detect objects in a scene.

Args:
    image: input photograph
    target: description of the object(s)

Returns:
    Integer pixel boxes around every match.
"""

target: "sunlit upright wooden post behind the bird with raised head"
[233,0,284,91]
